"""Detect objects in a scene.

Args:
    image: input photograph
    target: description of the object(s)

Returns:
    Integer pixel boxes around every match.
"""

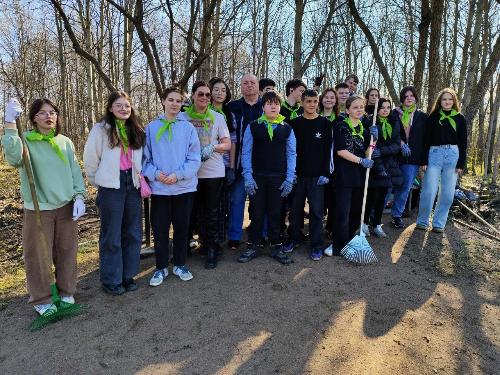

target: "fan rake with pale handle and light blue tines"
[340,100,378,264]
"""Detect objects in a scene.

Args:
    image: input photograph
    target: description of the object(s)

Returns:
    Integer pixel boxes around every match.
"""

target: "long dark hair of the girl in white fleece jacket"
[101,90,146,150]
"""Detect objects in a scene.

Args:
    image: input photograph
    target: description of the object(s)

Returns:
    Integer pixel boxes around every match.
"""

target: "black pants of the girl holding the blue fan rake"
[333,186,363,252]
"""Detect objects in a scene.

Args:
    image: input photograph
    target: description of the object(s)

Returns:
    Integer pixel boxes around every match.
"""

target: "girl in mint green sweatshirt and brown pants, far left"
[2,99,85,315]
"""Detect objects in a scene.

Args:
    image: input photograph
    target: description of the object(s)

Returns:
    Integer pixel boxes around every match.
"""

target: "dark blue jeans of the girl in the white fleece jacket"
[96,169,142,285]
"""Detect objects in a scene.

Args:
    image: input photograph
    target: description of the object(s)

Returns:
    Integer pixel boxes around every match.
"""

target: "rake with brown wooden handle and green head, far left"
[16,119,84,331]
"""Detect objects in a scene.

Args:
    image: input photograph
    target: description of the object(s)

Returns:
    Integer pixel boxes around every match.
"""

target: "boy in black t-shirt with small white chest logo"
[284,90,332,260]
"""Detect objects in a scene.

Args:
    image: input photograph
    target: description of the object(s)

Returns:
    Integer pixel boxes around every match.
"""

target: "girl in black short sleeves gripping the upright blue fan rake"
[324,95,378,256]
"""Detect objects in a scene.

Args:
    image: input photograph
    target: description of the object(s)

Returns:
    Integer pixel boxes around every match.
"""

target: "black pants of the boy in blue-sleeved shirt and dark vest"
[248,175,284,245]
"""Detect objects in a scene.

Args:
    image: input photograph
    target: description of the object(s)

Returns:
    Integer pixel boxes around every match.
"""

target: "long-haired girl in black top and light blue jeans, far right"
[417,88,467,233]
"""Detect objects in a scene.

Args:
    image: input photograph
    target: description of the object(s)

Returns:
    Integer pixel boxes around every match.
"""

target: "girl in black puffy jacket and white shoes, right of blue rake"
[363,98,403,237]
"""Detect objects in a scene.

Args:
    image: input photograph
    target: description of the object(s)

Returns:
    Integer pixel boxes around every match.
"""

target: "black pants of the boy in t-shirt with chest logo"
[288,177,325,249]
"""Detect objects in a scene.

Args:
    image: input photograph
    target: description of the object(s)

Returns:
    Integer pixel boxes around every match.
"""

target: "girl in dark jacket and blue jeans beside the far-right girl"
[391,86,427,228]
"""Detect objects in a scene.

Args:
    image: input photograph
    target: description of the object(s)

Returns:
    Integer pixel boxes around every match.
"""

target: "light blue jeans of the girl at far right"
[417,145,458,228]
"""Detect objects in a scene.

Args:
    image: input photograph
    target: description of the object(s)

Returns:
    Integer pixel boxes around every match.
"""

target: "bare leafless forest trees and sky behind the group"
[0,0,500,182]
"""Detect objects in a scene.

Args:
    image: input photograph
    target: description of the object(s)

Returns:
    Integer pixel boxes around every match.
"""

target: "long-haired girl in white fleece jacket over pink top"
[83,91,146,295]
